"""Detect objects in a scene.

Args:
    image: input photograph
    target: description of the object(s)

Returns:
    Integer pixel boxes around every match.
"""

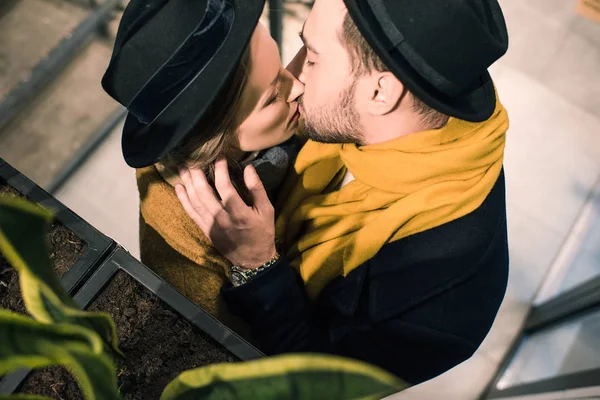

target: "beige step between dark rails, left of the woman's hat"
[0,0,118,187]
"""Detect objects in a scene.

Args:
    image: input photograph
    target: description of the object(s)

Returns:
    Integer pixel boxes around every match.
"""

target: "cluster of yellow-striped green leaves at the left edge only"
[0,197,122,400]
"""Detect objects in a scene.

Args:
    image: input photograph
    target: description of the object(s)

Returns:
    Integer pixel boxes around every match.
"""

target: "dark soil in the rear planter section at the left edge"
[0,181,86,314]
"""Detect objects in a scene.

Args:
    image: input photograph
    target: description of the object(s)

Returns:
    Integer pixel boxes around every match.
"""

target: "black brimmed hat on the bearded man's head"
[344,0,508,122]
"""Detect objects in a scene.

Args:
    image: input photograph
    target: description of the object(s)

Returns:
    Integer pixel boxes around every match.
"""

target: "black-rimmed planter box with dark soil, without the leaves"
[0,160,263,400]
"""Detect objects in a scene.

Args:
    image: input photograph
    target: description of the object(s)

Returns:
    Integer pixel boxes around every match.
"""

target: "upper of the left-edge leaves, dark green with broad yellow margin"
[0,196,123,356]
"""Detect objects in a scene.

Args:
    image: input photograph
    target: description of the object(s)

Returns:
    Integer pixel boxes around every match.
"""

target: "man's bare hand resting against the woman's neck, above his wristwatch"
[175,160,276,268]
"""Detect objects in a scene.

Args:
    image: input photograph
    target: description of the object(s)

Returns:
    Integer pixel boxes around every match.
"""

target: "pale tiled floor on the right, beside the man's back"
[392,0,600,400]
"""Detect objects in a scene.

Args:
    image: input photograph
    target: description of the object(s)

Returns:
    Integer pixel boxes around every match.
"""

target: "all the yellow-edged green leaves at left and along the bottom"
[0,196,407,400]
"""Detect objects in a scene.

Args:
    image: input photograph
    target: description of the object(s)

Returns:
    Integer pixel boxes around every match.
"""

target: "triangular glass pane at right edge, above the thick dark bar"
[535,185,600,305]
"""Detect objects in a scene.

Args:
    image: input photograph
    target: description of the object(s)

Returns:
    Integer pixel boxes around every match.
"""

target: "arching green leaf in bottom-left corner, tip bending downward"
[0,309,120,400]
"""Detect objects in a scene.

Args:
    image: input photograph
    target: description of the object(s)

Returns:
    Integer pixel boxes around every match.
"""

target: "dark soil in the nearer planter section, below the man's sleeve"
[21,271,238,400]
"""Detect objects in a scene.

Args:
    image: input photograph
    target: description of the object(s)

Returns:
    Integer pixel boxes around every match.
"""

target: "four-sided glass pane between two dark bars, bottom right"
[497,308,600,390]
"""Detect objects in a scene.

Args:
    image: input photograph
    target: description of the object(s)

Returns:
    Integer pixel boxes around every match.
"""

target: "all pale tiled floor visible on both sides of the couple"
[51,0,600,400]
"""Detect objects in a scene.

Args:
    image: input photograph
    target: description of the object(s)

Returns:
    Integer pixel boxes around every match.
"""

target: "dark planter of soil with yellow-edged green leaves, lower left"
[0,158,405,399]
